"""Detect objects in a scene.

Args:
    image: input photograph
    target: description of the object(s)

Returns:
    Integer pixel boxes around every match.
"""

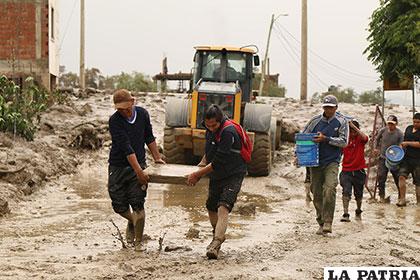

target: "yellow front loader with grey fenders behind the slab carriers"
[163,46,277,176]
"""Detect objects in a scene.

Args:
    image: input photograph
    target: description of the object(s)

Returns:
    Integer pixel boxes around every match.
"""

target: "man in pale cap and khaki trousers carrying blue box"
[303,95,349,234]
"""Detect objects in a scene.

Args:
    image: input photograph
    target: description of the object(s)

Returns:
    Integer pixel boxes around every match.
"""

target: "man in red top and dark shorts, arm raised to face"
[340,120,369,222]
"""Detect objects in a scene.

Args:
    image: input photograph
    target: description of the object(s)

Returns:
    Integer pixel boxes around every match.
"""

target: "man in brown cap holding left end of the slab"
[108,89,165,251]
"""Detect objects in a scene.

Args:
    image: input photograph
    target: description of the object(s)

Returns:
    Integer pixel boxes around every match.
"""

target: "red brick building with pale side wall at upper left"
[0,0,59,90]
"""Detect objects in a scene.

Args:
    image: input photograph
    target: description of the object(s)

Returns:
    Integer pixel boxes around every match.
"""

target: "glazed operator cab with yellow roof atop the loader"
[193,47,259,102]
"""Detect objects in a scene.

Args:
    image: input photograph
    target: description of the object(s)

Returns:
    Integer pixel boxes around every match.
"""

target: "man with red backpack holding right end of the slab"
[188,105,246,259]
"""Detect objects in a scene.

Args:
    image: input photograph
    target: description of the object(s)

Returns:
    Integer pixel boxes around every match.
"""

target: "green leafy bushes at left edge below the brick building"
[0,76,49,140]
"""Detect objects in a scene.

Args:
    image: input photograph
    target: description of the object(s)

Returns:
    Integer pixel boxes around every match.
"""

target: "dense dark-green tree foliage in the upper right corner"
[364,0,420,79]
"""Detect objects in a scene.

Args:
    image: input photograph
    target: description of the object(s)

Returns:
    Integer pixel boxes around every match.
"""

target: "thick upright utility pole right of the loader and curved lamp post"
[300,0,308,100]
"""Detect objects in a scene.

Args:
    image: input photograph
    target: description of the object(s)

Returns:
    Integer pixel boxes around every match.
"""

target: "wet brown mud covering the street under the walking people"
[0,94,420,279]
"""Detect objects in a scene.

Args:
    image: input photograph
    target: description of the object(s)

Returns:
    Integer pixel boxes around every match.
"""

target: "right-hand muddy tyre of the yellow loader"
[248,132,272,177]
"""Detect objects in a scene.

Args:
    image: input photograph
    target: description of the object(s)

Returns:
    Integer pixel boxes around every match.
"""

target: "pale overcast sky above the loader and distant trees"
[59,0,416,103]
